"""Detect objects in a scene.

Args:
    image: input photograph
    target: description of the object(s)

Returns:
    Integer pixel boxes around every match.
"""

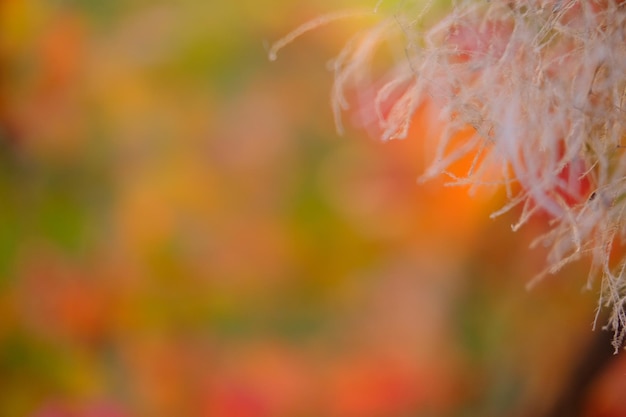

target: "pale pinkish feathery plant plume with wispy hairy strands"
[273,0,626,350]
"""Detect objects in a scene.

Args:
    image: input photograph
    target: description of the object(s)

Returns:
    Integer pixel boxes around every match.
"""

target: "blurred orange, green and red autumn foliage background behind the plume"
[0,0,626,417]
